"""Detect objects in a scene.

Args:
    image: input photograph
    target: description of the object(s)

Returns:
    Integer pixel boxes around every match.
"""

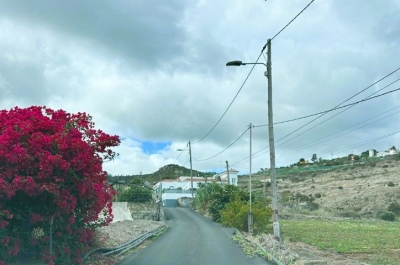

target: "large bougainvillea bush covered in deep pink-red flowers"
[0,106,120,264]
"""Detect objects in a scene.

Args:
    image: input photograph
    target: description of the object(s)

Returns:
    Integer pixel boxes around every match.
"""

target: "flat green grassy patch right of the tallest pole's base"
[281,220,400,254]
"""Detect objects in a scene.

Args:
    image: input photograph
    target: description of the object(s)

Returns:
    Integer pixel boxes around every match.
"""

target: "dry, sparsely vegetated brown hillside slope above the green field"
[239,159,400,218]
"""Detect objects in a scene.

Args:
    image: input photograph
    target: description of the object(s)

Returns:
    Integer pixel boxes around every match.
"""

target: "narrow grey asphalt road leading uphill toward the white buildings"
[119,208,269,265]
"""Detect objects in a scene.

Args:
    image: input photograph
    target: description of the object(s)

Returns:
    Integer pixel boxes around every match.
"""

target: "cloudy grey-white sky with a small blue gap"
[0,0,400,175]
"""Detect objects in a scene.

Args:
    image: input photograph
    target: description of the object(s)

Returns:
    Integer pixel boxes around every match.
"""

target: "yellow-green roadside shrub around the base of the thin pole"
[220,198,272,234]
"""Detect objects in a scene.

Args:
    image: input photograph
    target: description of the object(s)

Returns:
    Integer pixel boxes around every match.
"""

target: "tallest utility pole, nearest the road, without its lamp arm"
[266,39,281,240]
